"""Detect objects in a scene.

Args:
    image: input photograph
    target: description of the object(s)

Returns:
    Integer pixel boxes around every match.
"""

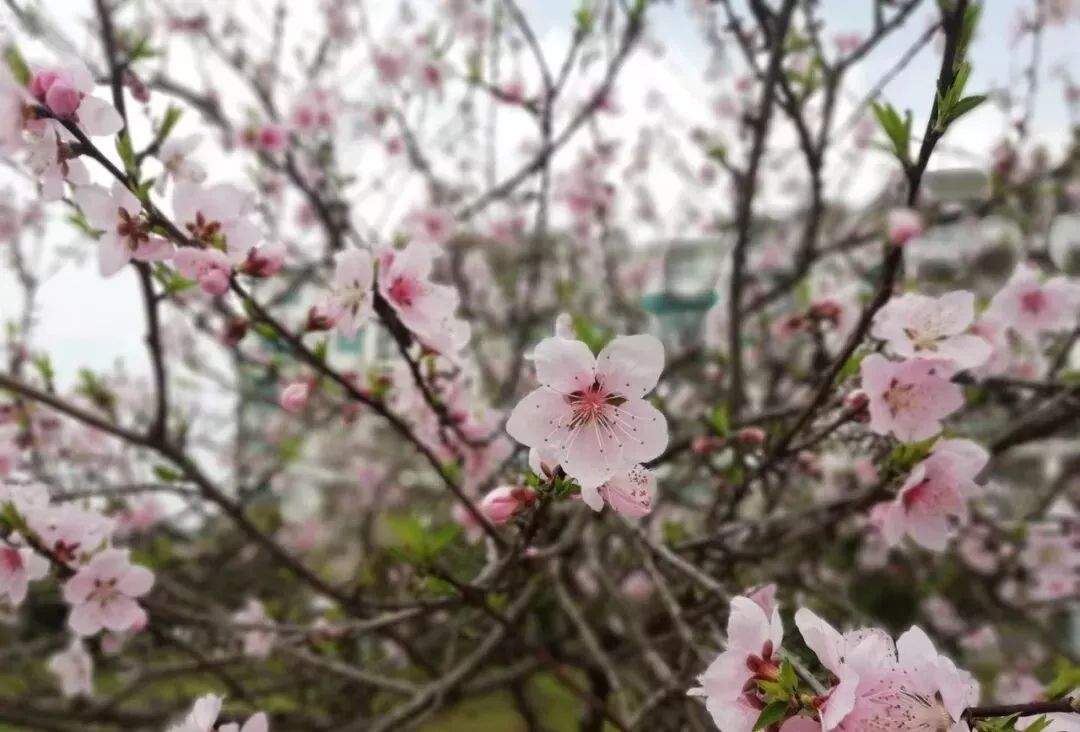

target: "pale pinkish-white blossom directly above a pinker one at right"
[870,290,991,369]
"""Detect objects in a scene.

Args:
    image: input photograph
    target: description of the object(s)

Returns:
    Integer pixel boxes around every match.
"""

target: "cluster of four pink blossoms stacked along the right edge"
[861,263,1080,552]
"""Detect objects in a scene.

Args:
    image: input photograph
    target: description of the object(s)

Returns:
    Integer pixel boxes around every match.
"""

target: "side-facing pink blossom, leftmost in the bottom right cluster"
[688,596,784,732]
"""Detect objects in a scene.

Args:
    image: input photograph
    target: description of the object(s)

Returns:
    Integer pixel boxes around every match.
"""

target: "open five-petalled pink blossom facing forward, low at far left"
[64,548,153,636]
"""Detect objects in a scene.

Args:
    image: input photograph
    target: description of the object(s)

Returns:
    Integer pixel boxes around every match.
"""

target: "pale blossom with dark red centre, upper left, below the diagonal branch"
[75,180,173,277]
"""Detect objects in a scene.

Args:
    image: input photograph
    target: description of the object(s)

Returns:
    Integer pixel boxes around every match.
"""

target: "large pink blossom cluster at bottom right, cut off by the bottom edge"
[690,587,978,732]
